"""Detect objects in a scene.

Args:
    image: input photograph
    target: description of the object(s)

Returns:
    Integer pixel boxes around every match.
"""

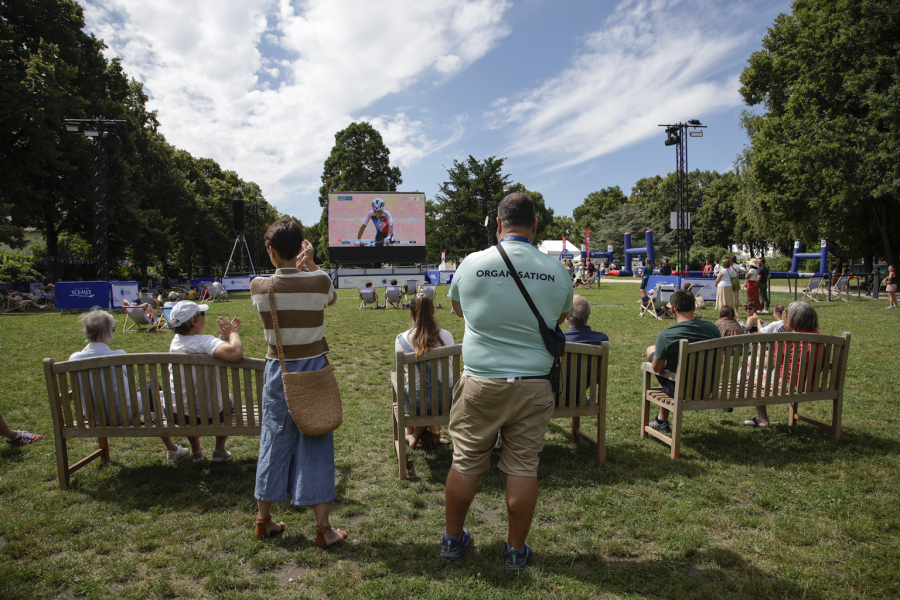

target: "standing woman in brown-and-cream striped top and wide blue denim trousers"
[250,221,347,548]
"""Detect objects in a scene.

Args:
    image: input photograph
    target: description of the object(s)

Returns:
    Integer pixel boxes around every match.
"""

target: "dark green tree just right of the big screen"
[425,156,509,263]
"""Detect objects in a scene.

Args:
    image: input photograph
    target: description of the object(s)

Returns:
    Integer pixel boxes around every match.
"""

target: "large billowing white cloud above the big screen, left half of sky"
[85,0,510,220]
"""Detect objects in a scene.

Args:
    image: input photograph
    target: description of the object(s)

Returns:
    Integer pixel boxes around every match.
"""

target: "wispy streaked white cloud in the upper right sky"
[486,0,760,170]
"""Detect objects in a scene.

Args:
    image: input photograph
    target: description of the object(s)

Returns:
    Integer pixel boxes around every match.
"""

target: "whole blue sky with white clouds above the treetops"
[81,0,790,229]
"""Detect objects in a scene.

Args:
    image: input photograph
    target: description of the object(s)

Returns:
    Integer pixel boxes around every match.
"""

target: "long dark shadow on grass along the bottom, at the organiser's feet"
[268,532,826,600]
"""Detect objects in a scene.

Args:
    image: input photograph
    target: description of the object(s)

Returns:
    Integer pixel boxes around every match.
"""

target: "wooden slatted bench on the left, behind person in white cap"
[44,352,266,490]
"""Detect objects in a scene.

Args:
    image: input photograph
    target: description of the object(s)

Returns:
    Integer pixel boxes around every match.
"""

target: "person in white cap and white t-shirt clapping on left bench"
[169,300,244,462]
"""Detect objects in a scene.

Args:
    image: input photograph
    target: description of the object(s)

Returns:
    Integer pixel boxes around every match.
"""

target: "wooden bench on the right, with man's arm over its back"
[641,333,850,459]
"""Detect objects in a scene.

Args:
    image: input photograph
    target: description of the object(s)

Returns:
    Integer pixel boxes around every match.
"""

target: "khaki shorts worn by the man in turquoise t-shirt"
[450,375,553,477]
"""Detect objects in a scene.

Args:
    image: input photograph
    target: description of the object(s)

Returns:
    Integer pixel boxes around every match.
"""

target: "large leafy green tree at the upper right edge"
[741,0,900,263]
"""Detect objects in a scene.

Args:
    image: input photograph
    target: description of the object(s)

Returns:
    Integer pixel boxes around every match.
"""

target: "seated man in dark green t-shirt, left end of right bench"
[647,290,722,432]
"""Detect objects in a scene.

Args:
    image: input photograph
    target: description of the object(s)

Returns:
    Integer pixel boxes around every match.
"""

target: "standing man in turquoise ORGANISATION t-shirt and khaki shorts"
[441,193,573,571]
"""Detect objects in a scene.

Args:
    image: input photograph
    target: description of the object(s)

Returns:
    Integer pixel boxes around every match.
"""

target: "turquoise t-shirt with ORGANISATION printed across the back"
[450,241,573,378]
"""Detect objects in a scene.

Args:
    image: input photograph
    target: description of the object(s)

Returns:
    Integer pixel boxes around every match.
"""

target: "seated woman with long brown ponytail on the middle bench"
[394,294,454,448]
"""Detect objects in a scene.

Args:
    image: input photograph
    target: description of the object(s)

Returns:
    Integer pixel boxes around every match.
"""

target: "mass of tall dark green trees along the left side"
[0,0,278,279]
